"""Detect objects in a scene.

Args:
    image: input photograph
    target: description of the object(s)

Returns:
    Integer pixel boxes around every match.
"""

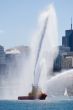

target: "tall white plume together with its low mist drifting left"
[0,5,58,99]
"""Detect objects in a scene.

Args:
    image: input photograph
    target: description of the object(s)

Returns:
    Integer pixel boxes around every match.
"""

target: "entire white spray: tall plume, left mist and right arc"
[0,5,73,99]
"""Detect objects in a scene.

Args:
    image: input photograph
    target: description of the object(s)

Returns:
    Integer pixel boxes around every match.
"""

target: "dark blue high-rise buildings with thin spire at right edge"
[53,20,73,71]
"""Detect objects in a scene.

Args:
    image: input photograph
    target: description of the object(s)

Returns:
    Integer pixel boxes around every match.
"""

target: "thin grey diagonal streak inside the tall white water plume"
[34,17,48,85]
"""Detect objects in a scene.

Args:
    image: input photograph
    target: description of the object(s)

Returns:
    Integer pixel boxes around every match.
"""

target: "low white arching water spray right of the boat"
[45,70,73,98]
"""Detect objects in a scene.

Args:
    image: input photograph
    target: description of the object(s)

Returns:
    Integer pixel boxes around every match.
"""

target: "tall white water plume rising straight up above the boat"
[32,5,58,89]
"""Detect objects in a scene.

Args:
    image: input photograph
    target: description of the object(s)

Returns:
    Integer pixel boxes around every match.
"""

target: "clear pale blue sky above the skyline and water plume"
[0,0,73,48]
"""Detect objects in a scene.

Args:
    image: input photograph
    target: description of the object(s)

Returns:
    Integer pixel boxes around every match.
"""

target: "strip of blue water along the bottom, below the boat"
[0,100,73,110]
